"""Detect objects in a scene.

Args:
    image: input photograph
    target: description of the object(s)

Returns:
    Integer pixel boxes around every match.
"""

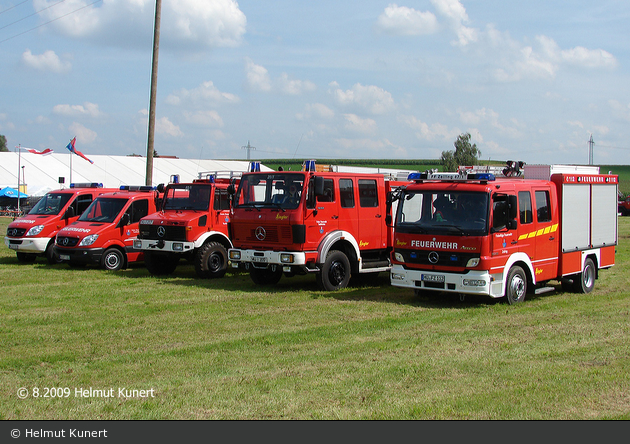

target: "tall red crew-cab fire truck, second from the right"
[228,161,408,291]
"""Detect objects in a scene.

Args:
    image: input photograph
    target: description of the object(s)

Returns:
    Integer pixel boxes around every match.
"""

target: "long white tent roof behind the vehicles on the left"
[0,152,271,196]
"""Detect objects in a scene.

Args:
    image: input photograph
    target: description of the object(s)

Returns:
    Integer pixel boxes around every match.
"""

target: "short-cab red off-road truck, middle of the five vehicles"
[134,171,242,278]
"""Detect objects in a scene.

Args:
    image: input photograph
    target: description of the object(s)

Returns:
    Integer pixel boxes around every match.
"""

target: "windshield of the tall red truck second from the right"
[235,173,304,210]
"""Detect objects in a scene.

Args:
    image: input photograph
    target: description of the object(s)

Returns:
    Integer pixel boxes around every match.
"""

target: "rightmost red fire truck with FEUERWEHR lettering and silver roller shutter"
[390,162,618,304]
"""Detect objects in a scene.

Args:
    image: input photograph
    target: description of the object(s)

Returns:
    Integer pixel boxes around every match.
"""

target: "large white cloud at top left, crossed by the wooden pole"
[33,0,247,47]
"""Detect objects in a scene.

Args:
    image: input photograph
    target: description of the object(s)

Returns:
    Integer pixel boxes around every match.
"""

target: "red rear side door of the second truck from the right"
[357,178,387,250]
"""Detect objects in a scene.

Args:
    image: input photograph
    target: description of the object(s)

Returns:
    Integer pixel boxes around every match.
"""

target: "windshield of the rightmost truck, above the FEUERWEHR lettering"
[396,191,489,236]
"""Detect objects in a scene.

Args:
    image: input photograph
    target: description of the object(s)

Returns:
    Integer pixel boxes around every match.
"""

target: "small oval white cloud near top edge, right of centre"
[376,4,438,35]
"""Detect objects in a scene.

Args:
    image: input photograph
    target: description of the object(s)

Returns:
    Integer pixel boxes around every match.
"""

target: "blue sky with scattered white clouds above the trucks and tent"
[0,0,630,164]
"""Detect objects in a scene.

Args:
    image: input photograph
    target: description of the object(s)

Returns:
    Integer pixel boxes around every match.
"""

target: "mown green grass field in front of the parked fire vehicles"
[0,217,630,420]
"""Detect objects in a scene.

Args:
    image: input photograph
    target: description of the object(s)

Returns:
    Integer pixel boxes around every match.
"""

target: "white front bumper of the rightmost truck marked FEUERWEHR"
[389,264,502,297]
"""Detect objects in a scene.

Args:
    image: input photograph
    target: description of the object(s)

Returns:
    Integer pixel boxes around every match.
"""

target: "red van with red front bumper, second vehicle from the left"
[54,185,160,271]
